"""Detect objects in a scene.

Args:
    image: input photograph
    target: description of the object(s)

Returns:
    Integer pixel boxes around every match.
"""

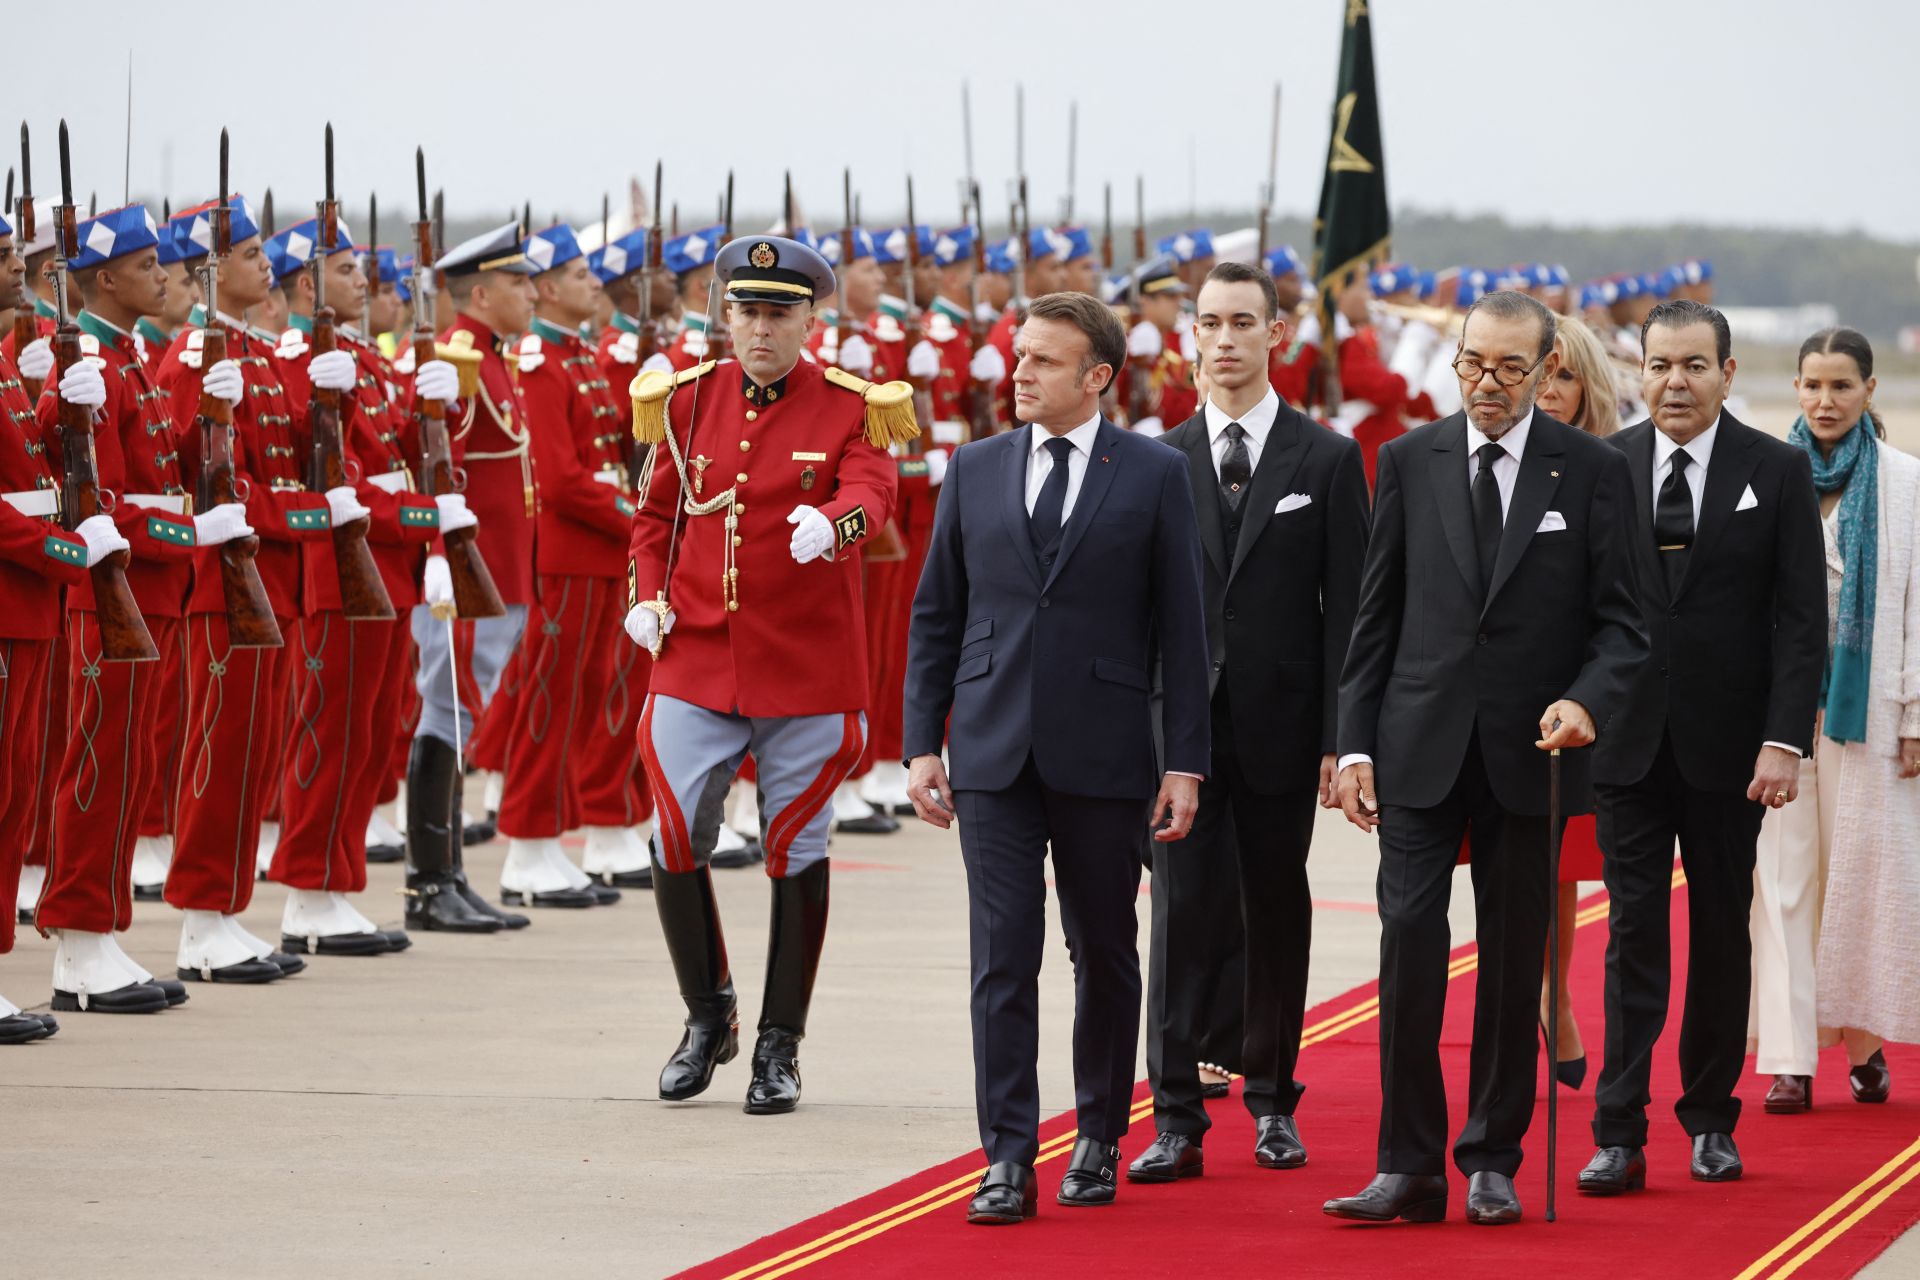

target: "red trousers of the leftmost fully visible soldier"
[35,608,182,933]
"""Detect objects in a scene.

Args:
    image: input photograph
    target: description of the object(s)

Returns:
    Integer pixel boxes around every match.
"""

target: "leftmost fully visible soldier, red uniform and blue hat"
[35,205,241,1011]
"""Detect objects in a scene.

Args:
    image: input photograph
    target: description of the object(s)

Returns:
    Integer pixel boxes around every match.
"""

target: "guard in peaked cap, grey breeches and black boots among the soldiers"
[407,223,538,933]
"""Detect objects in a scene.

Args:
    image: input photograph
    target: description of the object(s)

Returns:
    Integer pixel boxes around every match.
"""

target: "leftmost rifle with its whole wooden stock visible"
[54,121,159,662]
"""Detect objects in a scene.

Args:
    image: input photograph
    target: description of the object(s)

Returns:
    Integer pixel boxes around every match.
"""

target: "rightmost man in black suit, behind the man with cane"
[1580,299,1826,1196]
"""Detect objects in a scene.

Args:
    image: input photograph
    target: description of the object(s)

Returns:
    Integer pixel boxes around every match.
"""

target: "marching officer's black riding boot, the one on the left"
[653,865,739,1102]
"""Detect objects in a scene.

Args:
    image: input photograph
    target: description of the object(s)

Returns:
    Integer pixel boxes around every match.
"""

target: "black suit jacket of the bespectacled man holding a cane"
[1338,409,1647,816]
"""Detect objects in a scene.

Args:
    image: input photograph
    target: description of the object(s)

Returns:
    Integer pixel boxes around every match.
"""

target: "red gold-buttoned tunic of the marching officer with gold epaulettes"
[630,359,899,716]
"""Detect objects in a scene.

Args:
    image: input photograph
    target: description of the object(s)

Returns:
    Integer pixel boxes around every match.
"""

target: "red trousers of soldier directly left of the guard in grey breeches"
[267,610,411,892]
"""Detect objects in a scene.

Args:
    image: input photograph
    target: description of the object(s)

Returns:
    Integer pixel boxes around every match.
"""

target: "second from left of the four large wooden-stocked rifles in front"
[194,129,286,649]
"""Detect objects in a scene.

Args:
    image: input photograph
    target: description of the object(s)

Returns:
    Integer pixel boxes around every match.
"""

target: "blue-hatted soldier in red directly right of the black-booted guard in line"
[499,223,651,906]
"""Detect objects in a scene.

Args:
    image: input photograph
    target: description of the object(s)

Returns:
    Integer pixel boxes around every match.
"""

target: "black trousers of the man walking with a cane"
[1377,735,1565,1176]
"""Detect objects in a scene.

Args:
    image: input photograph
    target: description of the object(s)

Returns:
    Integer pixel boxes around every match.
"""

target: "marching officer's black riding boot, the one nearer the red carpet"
[747,858,828,1115]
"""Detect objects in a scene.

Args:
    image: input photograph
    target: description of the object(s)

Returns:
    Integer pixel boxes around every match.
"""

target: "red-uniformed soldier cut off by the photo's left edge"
[0,205,102,1044]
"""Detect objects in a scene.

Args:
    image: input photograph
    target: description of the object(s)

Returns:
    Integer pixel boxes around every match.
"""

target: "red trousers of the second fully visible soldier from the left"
[167,614,300,915]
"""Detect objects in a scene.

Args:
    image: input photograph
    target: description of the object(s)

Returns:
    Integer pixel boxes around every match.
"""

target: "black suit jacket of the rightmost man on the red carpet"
[1594,413,1826,793]
